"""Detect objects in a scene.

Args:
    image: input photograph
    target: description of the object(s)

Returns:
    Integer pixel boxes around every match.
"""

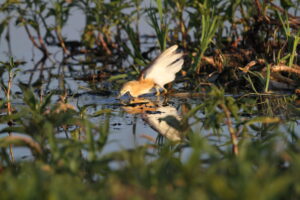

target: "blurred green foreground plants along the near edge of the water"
[0,83,300,199]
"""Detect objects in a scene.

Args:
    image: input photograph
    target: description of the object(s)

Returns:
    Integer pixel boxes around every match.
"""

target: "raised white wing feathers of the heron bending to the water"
[143,45,184,87]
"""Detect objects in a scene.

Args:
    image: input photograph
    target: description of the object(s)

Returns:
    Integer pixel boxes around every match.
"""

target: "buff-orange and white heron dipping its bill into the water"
[119,45,184,97]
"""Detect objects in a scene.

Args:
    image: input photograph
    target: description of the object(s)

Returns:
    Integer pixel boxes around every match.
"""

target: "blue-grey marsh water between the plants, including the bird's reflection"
[0,2,299,159]
